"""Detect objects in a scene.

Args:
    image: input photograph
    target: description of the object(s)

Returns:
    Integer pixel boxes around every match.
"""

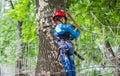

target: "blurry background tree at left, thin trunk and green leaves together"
[0,0,37,74]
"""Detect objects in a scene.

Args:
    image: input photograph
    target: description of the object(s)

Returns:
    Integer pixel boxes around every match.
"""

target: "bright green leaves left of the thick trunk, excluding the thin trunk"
[0,0,38,62]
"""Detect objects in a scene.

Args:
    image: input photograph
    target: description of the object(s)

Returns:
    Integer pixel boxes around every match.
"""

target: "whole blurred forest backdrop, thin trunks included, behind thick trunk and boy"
[0,0,120,76]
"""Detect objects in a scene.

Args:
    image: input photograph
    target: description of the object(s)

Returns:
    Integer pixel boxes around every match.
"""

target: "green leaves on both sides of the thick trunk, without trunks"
[0,0,120,76]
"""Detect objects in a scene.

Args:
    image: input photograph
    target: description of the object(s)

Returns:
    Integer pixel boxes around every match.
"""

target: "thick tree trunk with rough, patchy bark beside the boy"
[35,0,66,76]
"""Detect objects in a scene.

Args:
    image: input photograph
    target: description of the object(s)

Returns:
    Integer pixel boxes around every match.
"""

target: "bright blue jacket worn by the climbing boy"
[54,24,80,40]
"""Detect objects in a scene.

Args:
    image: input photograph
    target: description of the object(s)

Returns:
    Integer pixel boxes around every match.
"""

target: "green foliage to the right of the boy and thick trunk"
[67,0,120,76]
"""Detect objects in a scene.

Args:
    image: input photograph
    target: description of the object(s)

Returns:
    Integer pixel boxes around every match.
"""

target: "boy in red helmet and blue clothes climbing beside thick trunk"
[52,10,80,76]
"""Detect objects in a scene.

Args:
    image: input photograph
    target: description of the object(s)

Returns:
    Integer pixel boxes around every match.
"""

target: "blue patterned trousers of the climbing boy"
[58,41,76,76]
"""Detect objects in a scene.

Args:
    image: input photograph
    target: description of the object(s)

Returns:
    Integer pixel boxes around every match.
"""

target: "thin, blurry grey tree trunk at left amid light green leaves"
[9,0,27,76]
